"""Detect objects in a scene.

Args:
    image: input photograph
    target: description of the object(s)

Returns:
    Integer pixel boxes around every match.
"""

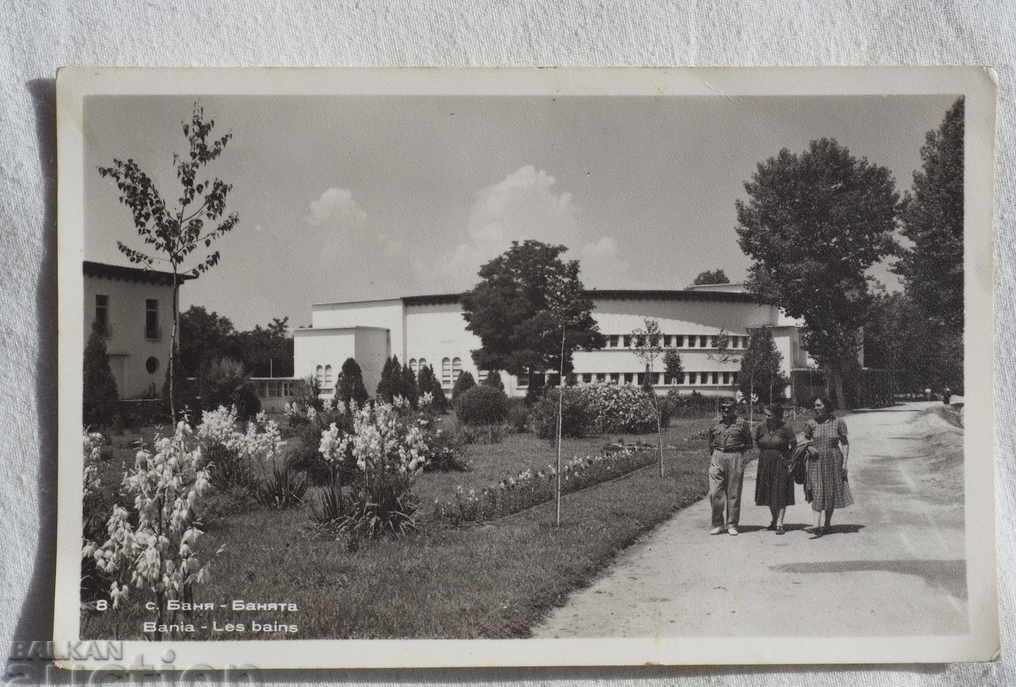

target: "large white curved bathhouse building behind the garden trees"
[294,285,809,396]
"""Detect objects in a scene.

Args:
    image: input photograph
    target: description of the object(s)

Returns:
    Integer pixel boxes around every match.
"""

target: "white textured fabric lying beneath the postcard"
[0,0,1016,686]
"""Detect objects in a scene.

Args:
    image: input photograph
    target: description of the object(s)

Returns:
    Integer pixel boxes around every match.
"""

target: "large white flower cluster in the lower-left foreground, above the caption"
[82,422,221,608]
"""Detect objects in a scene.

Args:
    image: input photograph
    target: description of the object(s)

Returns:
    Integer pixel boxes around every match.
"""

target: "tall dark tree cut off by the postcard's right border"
[895,98,964,331]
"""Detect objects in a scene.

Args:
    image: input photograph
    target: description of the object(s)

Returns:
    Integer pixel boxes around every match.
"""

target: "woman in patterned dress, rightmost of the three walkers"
[805,397,853,538]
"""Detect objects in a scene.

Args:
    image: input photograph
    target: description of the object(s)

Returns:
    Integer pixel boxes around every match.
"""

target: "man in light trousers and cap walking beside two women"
[709,398,752,537]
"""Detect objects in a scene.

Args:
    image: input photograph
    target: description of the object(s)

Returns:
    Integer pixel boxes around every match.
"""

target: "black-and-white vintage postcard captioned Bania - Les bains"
[55,67,999,670]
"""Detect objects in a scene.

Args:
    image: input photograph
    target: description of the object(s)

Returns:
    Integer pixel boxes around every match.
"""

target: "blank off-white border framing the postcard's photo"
[54,67,1000,670]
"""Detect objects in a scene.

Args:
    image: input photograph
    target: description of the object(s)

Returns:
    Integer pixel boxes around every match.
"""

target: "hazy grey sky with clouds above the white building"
[84,96,954,329]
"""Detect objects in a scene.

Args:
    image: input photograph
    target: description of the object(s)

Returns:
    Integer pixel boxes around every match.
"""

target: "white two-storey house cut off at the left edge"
[82,260,184,398]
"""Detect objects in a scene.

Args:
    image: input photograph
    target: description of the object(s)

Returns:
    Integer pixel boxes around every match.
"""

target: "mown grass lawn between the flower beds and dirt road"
[82,412,727,639]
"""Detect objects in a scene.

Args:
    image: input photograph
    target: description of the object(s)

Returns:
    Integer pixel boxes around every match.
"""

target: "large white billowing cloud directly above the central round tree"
[445,165,628,287]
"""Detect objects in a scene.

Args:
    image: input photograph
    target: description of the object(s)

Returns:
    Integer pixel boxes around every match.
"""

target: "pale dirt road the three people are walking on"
[534,403,966,637]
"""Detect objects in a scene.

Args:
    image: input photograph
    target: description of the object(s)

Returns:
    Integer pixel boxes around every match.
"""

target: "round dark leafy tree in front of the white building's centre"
[462,240,604,376]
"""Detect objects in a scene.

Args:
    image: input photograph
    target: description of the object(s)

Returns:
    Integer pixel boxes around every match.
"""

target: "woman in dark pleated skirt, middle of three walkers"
[755,405,798,535]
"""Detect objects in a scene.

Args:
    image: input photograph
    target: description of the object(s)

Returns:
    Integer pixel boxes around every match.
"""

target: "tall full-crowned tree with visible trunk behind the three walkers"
[737,138,899,408]
